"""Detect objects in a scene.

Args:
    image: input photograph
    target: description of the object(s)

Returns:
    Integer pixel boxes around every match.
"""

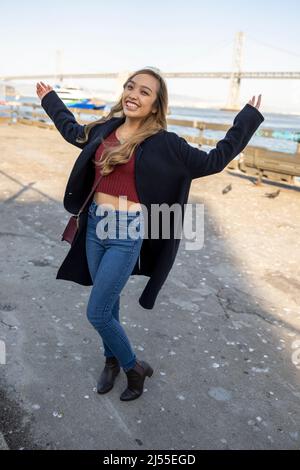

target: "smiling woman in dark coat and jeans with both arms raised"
[36,67,264,401]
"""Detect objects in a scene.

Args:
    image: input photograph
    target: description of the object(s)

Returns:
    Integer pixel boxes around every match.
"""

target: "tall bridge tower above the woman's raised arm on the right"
[224,31,244,111]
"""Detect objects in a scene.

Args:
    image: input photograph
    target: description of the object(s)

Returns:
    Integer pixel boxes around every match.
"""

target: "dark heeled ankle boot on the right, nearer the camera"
[120,359,153,401]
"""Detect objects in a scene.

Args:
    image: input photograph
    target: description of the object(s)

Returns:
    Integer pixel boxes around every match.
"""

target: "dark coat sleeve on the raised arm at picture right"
[177,103,264,179]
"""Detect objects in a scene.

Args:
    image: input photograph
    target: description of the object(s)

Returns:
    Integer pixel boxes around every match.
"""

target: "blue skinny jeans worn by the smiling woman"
[86,201,144,371]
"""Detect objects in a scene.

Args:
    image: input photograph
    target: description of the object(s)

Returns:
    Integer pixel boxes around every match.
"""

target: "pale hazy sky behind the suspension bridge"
[0,0,300,114]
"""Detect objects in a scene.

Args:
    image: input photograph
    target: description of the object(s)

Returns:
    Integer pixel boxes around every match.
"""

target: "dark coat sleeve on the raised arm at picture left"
[41,90,87,149]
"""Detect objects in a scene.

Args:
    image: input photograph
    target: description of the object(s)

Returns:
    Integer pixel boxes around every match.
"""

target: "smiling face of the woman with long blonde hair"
[122,73,159,119]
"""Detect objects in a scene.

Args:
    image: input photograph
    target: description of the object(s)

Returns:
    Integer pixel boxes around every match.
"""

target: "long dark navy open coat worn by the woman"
[41,90,264,309]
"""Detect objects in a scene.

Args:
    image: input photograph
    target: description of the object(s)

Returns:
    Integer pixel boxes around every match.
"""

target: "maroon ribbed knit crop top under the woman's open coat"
[94,131,140,202]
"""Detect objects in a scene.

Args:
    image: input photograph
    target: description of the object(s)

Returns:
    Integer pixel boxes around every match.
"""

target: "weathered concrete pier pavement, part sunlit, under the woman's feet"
[0,124,300,450]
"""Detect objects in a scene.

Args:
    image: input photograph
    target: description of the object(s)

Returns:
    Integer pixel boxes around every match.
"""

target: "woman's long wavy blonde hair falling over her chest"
[77,68,168,176]
